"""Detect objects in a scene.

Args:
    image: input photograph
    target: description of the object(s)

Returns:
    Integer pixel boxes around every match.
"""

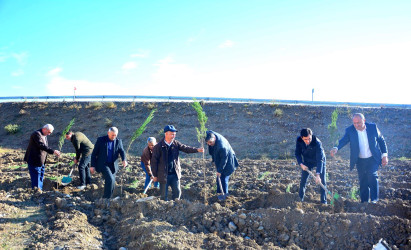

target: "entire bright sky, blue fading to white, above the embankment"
[0,0,411,104]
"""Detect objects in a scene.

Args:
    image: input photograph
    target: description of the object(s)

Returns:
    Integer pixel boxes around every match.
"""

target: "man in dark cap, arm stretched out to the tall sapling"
[151,125,204,200]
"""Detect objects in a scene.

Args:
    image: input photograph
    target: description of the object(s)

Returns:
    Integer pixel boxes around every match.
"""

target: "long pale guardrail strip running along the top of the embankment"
[0,95,411,109]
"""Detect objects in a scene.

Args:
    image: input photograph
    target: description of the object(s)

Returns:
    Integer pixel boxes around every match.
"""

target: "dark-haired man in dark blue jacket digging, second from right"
[295,128,327,204]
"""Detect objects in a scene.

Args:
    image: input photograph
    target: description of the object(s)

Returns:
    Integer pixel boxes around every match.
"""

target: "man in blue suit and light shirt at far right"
[331,113,388,203]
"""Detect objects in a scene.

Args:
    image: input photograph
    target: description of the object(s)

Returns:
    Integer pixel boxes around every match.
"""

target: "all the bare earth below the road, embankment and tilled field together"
[0,103,411,249]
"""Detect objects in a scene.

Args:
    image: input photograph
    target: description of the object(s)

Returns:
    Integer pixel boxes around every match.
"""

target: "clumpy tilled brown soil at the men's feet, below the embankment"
[0,151,411,249]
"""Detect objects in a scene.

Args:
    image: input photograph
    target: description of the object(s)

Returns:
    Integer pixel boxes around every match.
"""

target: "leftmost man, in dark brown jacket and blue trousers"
[24,124,60,190]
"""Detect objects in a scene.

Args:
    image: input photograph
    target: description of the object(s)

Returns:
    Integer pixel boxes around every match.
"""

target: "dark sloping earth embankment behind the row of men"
[0,102,411,159]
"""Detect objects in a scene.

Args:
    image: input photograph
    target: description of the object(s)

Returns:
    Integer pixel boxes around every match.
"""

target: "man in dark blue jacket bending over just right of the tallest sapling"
[205,130,238,199]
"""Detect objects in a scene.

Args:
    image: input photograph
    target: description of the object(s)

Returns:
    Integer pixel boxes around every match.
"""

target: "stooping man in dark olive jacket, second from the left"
[66,131,94,190]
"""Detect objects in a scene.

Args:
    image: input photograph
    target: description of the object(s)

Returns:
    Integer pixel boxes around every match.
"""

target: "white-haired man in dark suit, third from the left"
[90,127,127,199]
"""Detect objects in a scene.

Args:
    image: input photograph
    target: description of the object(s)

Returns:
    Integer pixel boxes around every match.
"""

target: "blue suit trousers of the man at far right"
[357,157,379,202]
